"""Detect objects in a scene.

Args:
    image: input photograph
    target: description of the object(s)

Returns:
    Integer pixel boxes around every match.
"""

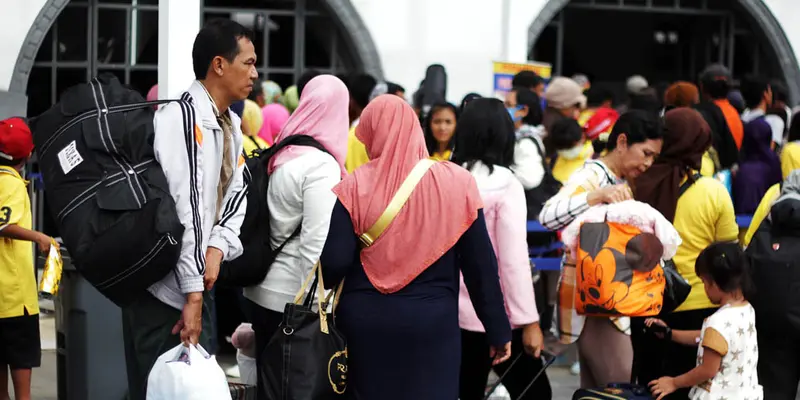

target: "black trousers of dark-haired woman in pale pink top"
[459,329,553,400]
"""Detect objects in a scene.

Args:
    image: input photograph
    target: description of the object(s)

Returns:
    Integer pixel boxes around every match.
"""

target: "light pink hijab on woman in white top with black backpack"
[265,75,350,177]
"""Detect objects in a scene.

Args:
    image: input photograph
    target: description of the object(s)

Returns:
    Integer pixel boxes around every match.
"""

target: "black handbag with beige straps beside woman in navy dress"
[258,263,347,400]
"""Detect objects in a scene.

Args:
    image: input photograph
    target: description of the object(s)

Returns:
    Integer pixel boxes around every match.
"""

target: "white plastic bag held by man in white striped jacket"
[147,344,231,400]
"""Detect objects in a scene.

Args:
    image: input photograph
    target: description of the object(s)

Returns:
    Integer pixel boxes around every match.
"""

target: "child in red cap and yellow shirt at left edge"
[0,118,52,400]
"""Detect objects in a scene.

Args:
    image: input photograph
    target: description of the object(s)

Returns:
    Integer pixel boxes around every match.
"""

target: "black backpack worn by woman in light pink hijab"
[218,135,328,287]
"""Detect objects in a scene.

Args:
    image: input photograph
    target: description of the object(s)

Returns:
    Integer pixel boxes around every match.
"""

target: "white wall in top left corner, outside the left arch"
[0,0,45,91]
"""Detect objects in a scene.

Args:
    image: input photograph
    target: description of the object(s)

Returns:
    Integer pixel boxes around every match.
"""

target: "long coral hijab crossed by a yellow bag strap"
[333,94,483,293]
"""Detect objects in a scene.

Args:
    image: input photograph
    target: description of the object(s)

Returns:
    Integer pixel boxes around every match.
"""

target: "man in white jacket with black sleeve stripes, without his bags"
[123,20,258,400]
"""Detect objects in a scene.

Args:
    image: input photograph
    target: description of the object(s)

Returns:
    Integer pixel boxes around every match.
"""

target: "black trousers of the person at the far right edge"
[756,323,800,400]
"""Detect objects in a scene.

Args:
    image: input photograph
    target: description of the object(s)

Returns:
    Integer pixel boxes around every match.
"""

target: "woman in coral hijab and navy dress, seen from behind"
[321,95,511,400]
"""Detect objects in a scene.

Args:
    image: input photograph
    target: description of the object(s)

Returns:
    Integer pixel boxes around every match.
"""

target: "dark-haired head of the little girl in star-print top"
[694,242,752,304]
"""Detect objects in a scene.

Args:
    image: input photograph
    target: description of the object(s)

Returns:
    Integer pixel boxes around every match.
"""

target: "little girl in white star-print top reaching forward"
[646,242,764,400]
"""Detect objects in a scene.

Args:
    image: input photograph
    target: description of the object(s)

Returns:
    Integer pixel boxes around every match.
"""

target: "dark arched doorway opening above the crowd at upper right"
[528,0,800,102]
